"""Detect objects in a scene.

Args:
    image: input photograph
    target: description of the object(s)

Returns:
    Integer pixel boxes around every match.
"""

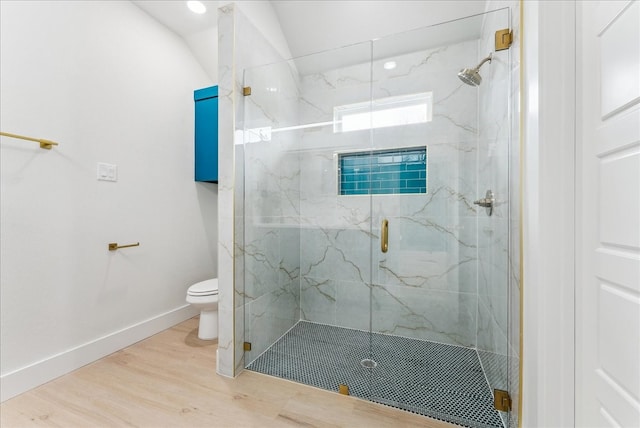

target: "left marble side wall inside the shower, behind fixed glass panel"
[242,57,300,364]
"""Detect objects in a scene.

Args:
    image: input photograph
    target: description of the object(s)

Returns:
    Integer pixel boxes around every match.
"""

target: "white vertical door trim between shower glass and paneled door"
[521,0,576,428]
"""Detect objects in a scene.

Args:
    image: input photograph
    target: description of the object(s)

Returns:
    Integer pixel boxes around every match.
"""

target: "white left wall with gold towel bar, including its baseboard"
[0,1,217,400]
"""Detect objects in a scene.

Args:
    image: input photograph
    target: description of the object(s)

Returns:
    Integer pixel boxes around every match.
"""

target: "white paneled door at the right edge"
[576,0,640,427]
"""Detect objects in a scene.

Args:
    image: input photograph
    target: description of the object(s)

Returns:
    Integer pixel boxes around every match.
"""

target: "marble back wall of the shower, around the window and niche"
[300,38,478,347]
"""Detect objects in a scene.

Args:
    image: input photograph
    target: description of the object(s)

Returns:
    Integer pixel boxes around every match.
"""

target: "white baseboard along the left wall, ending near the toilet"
[0,305,198,402]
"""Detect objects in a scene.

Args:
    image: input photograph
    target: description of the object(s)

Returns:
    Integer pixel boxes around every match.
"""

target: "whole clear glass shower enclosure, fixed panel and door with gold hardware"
[236,9,511,427]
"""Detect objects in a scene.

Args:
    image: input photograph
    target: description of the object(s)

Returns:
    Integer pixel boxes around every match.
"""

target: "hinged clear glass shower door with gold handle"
[371,9,510,426]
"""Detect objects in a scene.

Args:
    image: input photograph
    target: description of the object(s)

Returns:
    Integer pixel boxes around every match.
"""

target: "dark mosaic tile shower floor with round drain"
[247,321,502,428]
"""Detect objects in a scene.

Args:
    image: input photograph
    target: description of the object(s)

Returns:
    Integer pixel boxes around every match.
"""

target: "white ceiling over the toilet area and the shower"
[133,0,485,81]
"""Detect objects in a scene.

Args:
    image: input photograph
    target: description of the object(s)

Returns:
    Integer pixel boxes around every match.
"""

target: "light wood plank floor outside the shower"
[0,318,455,428]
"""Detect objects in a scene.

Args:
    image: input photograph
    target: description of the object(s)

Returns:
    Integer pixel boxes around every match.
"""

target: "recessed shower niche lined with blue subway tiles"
[338,146,427,195]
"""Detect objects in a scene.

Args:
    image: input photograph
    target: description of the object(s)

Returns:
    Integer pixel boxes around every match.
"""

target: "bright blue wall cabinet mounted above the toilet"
[193,86,218,183]
